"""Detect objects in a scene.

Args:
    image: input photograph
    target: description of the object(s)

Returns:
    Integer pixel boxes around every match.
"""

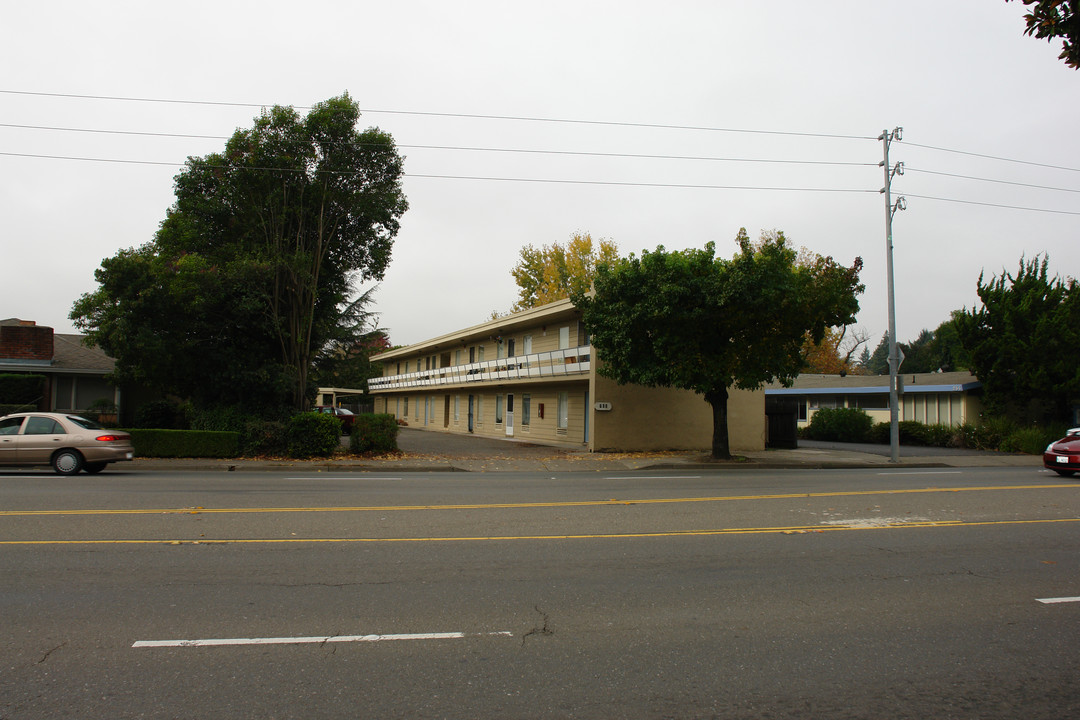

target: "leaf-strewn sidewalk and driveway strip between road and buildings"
[126,427,1042,473]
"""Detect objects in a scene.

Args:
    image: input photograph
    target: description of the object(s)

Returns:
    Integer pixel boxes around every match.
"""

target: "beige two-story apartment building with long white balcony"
[368,300,766,451]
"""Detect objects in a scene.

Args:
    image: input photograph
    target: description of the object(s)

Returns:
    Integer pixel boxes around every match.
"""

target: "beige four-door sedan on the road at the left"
[0,412,135,475]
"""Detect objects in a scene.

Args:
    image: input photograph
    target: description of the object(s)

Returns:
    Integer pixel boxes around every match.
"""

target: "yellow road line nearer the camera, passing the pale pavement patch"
[0,517,1080,546]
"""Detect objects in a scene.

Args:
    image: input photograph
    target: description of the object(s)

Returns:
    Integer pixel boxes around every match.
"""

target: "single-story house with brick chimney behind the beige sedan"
[0,317,120,412]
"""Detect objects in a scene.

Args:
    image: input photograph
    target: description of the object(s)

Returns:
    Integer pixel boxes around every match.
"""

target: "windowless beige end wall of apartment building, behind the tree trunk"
[590,369,766,452]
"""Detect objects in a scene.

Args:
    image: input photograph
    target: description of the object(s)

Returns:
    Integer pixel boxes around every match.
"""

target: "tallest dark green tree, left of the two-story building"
[71,94,407,408]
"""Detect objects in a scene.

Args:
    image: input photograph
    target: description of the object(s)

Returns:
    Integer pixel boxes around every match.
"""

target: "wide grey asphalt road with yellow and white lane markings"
[0,468,1080,720]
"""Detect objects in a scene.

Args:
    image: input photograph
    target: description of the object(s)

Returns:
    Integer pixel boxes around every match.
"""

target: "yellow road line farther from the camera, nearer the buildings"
[0,483,1080,517]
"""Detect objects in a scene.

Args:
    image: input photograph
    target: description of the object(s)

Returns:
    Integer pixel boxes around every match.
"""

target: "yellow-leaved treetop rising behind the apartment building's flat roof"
[510,232,619,312]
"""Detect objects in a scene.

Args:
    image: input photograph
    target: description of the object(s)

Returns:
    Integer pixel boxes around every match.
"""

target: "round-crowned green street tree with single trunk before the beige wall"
[575,229,863,459]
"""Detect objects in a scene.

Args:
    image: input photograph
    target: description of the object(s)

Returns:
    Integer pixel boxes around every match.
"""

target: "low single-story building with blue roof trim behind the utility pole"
[765,371,983,427]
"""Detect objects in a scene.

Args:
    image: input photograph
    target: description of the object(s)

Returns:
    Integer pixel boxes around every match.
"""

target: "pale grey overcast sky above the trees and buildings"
[0,0,1080,350]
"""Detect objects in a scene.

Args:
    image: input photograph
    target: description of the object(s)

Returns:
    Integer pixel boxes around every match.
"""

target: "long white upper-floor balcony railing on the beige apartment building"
[367,345,592,393]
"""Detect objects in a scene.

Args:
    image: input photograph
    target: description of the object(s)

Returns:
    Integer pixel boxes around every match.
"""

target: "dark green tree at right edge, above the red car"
[953,255,1080,422]
